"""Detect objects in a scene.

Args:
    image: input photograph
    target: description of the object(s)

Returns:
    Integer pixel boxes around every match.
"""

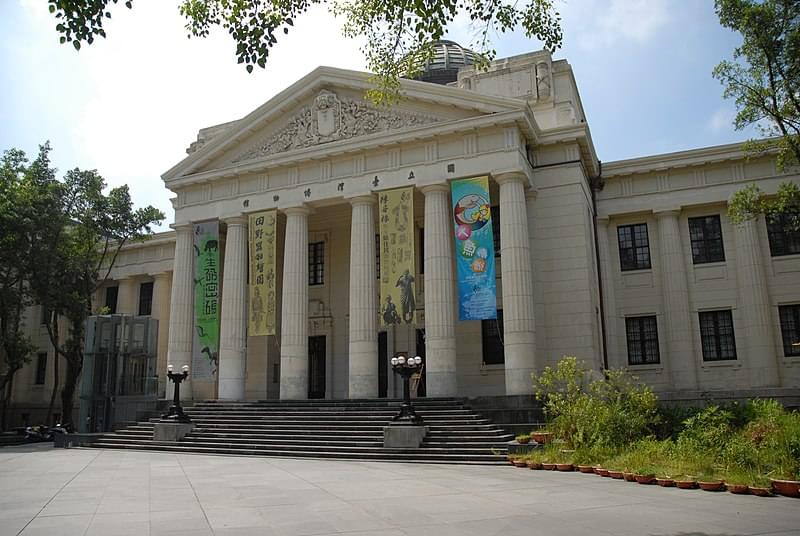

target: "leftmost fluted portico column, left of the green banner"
[163,223,194,400]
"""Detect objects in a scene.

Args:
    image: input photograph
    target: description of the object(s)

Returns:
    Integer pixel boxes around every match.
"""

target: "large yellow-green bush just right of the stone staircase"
[534,357,658,451]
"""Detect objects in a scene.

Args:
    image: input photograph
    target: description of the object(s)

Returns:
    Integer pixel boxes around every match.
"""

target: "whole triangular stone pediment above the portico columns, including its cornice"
[163,67,525,181]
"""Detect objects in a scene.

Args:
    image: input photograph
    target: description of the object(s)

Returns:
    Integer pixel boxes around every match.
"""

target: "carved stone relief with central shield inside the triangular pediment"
[232,91,438,163]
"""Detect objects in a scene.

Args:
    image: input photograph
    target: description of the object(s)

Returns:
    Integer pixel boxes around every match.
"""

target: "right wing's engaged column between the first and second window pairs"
[651,209,697,390]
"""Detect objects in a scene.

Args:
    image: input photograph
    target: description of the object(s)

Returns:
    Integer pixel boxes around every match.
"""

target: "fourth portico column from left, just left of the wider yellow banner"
[349,196,378,398]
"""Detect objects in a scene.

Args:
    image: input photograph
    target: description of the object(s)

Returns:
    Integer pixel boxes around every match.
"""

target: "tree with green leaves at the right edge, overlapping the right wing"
[714,0,800,230]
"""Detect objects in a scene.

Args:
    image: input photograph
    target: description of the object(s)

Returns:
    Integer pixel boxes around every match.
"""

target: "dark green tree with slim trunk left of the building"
[2,145,164,423]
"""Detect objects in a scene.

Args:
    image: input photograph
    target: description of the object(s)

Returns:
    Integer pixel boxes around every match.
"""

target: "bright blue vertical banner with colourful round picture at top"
[450,177,497,320]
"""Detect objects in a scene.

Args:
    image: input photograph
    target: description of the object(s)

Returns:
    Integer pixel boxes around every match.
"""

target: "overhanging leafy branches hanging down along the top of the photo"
[48,0,562,104]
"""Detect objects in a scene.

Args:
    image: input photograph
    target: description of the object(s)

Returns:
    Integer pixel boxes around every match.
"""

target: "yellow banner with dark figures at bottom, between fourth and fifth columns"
[378,187,416,326]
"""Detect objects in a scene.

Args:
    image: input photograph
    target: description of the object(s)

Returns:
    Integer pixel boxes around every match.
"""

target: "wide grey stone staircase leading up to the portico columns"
[87,398,513,464]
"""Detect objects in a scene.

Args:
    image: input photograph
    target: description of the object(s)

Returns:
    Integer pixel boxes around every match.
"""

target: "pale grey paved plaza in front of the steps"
[0,445,800,536]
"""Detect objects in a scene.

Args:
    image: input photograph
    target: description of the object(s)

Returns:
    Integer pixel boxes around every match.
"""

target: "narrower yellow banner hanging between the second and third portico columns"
[248,210,278,336]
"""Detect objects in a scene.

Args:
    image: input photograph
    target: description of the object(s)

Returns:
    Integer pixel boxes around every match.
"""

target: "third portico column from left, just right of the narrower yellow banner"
[281,207,310,400]
